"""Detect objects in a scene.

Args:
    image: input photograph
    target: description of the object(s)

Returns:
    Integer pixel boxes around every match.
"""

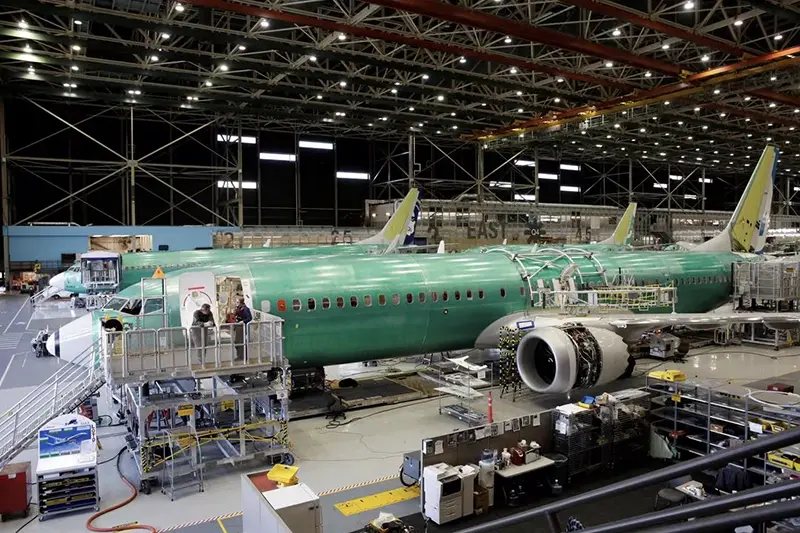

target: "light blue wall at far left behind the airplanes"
[3,226,239,261]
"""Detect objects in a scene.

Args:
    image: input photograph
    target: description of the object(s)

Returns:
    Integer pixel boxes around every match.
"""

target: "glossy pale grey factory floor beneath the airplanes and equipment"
[0,295,800,533]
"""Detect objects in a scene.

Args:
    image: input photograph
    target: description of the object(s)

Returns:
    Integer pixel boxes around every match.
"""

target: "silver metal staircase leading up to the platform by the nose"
[0,341,106,468]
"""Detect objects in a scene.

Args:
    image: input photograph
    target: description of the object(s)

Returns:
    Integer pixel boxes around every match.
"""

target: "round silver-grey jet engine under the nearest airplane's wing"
[517,324,628,393]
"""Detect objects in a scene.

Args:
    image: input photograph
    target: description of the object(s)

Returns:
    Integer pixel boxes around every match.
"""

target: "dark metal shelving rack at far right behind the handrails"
[645,376,800,484]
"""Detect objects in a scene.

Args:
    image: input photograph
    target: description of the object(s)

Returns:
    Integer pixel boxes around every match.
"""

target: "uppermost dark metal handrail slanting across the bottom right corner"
[457,427,800,533]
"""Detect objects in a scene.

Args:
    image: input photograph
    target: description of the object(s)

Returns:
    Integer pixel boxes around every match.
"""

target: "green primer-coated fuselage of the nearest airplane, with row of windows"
[103,250,761,368]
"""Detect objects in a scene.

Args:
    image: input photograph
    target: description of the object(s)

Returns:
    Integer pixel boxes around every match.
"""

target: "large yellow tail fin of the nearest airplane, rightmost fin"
[692,144,778,253]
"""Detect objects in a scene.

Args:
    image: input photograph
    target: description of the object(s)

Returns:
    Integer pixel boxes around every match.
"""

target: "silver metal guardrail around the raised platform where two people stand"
[103,314,283,384]
